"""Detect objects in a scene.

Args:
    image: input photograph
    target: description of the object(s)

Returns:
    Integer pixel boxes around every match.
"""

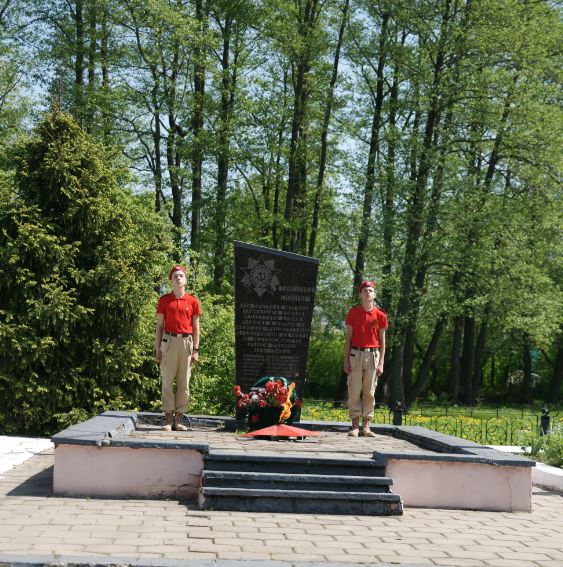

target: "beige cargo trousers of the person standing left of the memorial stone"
[160,333,194,413]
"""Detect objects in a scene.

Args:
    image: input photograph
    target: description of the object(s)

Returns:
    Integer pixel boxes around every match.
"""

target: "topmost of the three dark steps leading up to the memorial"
[204,451,385,477]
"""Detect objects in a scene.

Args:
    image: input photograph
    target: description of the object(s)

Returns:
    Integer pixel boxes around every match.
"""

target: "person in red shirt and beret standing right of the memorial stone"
[344,282,387,437]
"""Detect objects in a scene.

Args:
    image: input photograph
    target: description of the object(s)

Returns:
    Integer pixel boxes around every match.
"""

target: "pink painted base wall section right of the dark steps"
[385,459,532,512]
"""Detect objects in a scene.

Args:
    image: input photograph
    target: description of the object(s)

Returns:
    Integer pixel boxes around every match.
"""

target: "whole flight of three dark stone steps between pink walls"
[199,451,403,516]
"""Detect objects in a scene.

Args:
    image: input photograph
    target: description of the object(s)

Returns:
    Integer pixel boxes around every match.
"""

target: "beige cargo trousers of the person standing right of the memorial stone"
[348,348,379,418]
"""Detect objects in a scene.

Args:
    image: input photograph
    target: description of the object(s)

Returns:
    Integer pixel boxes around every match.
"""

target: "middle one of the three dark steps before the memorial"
[202,470,393,493]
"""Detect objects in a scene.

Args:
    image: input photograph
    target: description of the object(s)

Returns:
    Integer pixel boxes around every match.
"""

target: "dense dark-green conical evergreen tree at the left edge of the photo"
[0,112,170,434]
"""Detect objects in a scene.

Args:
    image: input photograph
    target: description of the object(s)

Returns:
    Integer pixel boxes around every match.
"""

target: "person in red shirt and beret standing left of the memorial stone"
[155,266,201,431]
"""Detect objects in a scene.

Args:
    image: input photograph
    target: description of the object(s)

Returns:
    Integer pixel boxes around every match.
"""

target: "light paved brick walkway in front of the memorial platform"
[0,449,563,567]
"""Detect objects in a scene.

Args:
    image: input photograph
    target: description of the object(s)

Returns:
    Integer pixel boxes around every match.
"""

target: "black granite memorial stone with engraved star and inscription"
[234,241,319,404]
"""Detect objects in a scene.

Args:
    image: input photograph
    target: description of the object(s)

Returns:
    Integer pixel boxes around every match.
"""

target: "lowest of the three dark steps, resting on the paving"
[199,486,403,516]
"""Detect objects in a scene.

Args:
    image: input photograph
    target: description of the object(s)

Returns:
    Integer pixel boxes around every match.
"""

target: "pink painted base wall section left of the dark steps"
[53,445,203,498]
